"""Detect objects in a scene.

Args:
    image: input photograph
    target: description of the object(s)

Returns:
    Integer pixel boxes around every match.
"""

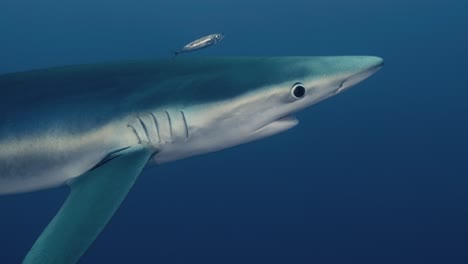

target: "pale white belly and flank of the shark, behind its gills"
[0,122,135,194]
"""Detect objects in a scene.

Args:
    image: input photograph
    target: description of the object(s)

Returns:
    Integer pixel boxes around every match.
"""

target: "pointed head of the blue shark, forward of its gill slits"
[150,56,383,163]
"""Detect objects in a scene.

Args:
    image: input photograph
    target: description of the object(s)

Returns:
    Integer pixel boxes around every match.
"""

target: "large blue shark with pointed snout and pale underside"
[0,56,383,263]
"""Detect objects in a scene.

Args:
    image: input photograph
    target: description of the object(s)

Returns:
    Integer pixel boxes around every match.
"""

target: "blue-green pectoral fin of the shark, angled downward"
[23,145,154,264]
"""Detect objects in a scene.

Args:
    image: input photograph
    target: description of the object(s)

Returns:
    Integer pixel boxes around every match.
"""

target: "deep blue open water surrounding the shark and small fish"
[0,0,468,264]
